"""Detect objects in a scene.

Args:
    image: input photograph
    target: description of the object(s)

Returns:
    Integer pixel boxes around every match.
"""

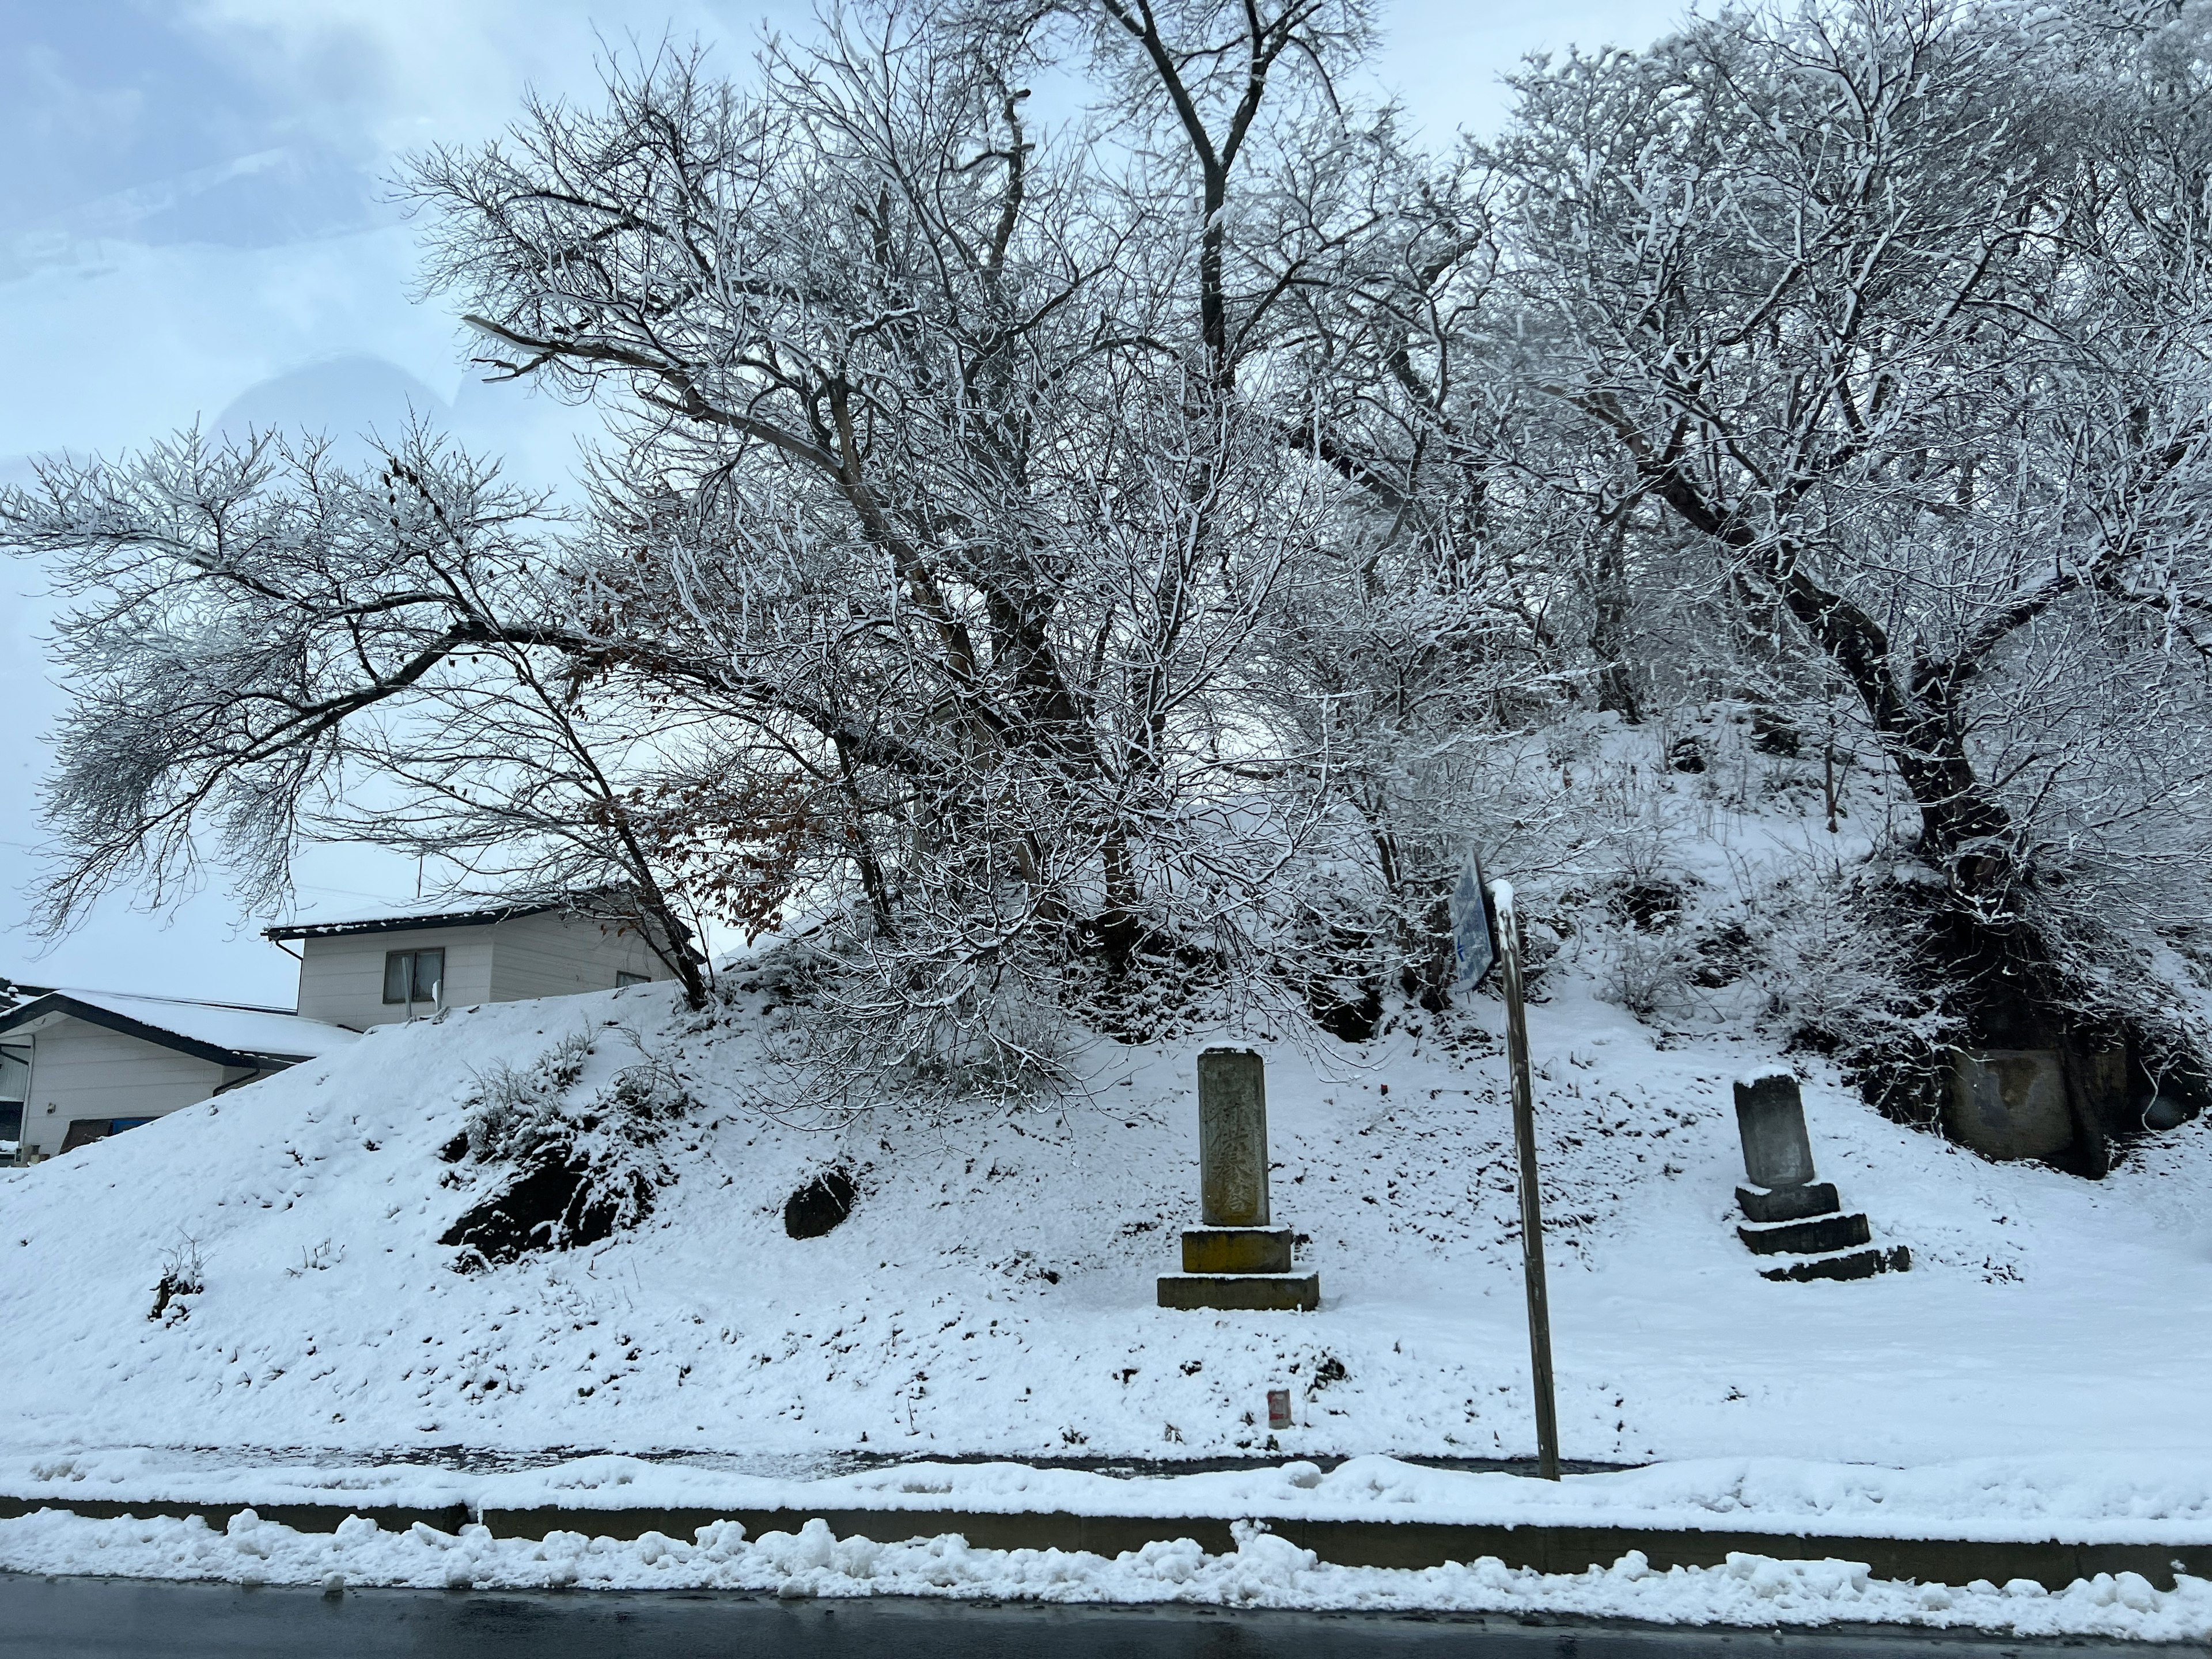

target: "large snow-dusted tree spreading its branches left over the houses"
[0,5,1389,1092]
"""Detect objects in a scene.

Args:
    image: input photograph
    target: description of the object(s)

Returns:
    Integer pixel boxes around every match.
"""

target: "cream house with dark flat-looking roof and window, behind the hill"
[268,903,690,1031]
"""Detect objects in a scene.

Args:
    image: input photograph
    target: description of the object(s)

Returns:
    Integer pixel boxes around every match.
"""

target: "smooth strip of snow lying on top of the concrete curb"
[13,1446,2212,1548]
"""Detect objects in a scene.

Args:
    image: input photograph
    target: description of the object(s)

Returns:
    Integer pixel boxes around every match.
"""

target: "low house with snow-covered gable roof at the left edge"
[0,991,356,1164]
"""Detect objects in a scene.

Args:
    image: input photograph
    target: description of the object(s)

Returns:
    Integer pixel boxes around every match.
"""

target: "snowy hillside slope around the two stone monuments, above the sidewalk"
[0,946,2212,1467]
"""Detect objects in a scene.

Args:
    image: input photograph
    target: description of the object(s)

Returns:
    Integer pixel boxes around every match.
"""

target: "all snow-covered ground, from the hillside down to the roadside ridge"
[0,809,2212,1635]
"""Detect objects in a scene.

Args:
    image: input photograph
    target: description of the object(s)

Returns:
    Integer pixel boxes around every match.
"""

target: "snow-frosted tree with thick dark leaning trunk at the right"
[1493,0,2212,1052]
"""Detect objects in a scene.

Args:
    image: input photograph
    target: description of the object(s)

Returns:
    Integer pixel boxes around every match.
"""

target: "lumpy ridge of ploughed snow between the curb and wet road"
[0,1511,2212,1641]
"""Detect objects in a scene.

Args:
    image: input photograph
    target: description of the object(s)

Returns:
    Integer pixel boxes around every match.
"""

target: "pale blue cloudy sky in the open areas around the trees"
[0,0,1681,1006]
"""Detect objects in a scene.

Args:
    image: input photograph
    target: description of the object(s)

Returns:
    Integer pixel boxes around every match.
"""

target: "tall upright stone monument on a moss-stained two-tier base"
[1159,1048,1320,1309]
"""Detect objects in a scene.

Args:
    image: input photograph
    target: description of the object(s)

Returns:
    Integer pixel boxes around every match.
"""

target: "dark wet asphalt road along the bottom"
[0,1575,2201,1659]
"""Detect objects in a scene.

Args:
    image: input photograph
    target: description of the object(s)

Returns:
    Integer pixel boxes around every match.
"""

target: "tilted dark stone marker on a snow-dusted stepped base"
[1736,1071,1911,1281]
